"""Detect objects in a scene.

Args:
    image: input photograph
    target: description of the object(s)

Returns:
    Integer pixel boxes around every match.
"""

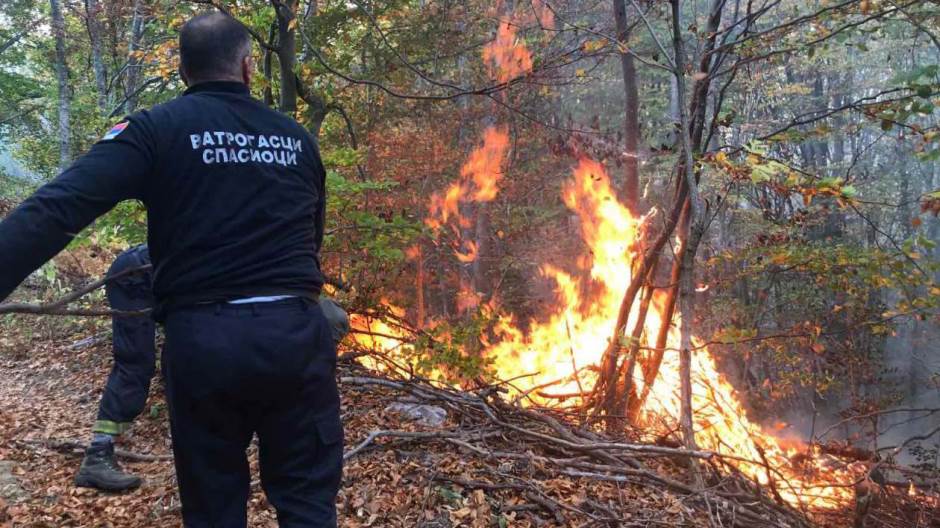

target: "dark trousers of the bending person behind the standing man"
[92,245,156,435]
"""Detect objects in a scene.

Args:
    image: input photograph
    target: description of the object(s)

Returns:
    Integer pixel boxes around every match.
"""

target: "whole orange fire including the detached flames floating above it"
[353,2,857,509]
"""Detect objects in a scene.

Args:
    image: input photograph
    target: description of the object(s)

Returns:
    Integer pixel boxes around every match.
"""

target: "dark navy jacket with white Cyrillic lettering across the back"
[0,82,326,308]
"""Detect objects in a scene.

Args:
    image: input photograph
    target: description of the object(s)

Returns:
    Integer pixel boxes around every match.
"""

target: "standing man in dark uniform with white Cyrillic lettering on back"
[0,13,343,528]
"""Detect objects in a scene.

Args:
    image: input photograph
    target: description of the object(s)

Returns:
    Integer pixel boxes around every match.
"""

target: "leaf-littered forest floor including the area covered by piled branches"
[0,318,940,528]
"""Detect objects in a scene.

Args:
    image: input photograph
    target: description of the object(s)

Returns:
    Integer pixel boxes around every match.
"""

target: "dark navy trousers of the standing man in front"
[163,298,343,528]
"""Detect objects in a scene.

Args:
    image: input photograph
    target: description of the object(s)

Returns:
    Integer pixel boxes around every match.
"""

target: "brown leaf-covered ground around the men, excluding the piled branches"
[0,318,698,528]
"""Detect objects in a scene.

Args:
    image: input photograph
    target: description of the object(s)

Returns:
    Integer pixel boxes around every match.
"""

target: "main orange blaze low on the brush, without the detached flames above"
[353,160,857,509]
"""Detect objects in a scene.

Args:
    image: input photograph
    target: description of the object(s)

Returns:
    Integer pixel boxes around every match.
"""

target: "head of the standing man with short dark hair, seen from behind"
[180,12,251,85]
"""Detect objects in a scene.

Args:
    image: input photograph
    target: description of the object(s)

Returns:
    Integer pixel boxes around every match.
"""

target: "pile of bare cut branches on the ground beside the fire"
[341,364,813,527]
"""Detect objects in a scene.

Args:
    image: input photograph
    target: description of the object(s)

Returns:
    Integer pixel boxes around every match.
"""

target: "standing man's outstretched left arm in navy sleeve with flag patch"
[0,116,154,301]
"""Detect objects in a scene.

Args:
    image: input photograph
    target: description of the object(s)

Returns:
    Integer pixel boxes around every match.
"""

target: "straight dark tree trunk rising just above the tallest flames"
[613,0,640,214]
